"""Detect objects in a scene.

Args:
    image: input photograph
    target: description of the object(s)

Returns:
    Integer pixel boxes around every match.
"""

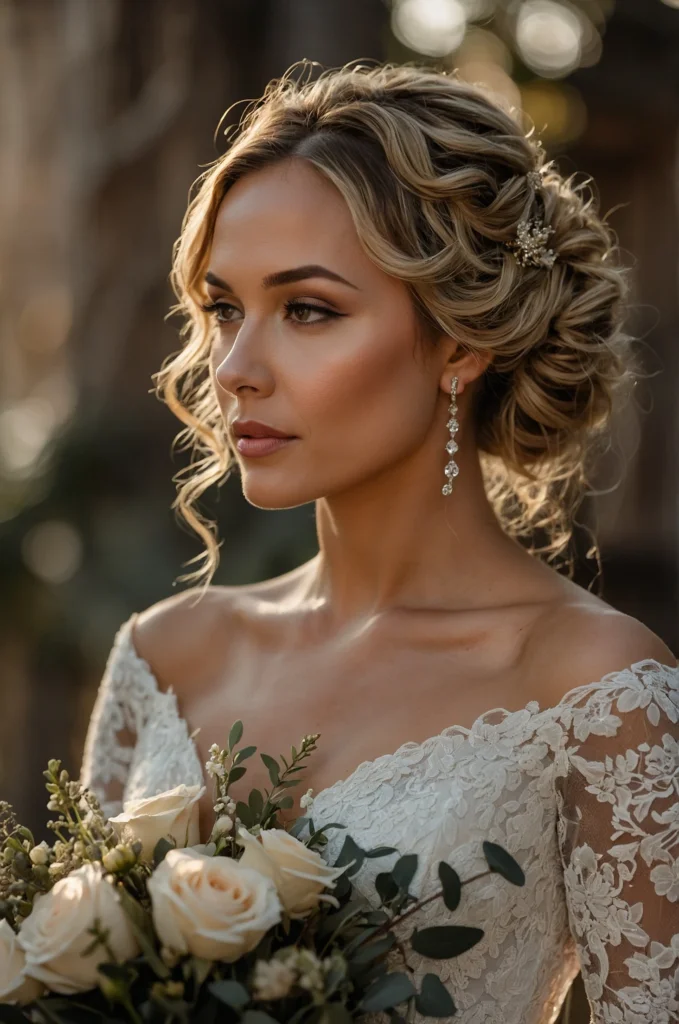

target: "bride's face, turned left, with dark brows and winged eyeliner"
[206,159,445,508]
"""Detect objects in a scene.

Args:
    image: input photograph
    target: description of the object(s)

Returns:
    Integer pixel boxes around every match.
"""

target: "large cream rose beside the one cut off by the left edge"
[18,863,139,995]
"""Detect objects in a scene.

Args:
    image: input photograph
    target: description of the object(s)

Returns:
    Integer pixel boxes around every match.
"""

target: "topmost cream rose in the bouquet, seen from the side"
[110,782,205,860]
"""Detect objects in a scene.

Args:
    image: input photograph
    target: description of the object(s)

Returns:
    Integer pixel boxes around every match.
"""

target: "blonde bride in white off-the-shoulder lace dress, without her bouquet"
[83,65,679,1024]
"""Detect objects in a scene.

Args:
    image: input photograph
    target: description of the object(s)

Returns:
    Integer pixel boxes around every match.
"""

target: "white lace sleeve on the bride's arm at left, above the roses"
[80,612,156,817]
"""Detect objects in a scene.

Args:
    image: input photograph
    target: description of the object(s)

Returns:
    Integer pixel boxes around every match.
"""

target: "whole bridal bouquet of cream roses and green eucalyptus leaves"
[0,721,524,1024]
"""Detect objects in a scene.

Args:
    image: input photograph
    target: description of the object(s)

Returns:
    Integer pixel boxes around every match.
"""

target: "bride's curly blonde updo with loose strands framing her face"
[154,61,636,586]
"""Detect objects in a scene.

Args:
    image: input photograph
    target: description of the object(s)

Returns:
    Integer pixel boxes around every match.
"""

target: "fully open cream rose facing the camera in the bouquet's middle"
[147,850,283,964]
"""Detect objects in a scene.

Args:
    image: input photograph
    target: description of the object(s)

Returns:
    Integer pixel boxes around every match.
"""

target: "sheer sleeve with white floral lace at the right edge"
[557,659,679,1024]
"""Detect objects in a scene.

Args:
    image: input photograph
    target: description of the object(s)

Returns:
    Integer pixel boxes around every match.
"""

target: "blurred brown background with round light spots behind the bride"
[0,0,679,1022]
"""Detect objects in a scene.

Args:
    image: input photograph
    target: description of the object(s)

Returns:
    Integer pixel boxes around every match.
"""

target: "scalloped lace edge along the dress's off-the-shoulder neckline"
[117,611,679,804]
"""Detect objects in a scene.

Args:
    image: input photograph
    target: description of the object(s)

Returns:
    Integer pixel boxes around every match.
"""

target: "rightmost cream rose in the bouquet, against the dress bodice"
[237,827,348,919]
